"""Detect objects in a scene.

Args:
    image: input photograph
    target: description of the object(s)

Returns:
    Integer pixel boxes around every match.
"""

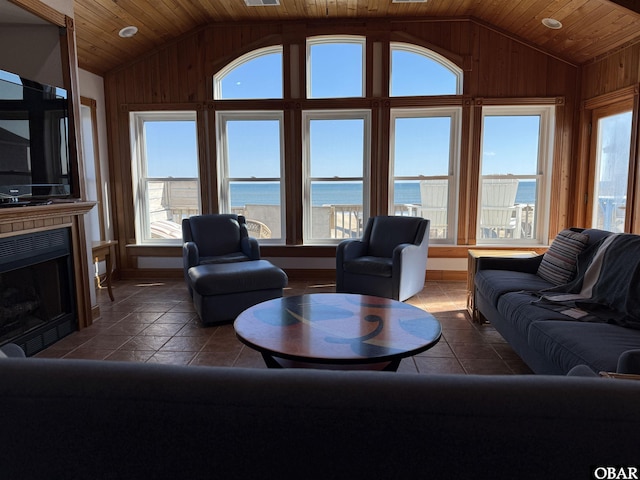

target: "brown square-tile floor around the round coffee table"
[37,279,531,374]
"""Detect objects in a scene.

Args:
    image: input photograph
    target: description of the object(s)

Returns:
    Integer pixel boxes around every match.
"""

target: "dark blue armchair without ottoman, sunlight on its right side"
[336,216,429,301]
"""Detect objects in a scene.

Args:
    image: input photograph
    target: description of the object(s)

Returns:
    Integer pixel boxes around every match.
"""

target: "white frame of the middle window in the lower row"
[302,109,371,245]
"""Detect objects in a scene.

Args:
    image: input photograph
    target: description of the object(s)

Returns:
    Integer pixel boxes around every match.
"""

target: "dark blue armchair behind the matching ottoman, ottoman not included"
[182,214,260,295]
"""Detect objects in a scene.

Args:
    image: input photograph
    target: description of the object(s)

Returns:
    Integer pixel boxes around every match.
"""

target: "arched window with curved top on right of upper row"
[389,42,462,97]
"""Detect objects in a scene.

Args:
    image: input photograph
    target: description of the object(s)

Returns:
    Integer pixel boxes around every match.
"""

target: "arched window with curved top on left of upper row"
[213,45,283,100]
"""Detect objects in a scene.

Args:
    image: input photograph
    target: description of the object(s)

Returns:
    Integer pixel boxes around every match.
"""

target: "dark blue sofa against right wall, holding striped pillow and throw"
[475,229,640,375]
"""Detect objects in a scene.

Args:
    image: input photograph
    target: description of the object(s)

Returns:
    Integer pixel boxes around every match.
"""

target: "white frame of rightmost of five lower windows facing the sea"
[476,104,556,245]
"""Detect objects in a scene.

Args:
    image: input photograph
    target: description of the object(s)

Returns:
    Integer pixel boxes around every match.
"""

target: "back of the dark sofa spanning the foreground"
[0,358,640,480]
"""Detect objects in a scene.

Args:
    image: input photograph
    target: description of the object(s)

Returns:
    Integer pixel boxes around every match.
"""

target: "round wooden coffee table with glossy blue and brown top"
[233,293,442,371]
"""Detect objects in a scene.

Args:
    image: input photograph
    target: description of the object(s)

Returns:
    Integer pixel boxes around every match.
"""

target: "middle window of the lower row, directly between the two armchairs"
[303,111,370,243]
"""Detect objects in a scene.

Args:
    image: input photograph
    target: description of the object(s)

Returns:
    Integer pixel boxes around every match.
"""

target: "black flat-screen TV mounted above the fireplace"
[0,70,75,206]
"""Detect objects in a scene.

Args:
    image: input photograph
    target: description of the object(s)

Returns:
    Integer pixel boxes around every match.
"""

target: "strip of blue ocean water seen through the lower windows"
[231,181,536,207]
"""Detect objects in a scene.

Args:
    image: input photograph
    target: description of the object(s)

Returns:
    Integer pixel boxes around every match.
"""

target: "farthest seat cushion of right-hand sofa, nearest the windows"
[475,270,553,306]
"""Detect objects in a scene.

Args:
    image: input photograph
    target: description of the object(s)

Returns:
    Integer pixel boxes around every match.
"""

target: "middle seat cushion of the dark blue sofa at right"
[496,292,580,339]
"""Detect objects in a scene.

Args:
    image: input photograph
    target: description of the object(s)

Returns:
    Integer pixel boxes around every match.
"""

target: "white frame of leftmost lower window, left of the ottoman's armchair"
[129,110,202,245]
